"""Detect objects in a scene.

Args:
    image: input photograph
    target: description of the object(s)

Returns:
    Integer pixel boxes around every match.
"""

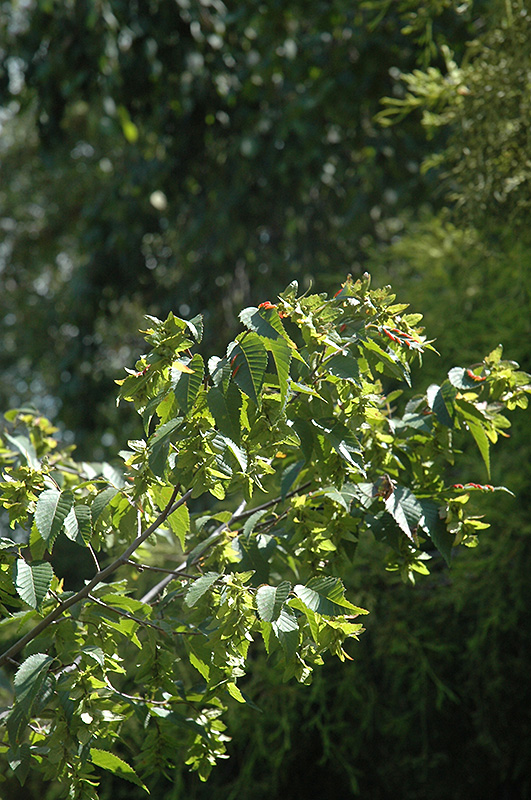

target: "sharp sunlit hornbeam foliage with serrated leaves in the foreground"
[0,275,530,799]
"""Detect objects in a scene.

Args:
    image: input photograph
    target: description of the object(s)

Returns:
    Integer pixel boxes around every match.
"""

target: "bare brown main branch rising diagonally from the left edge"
[0,487,192,666]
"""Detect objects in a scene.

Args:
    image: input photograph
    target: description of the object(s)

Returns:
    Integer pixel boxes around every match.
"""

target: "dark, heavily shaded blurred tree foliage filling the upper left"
[0,0,478,459]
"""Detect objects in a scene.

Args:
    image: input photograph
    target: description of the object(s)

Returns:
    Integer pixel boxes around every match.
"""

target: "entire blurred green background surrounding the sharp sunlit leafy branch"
[0,0,531,800]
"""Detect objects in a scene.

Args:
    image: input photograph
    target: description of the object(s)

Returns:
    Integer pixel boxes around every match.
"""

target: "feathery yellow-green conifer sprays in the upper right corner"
[378,0,531,231]
